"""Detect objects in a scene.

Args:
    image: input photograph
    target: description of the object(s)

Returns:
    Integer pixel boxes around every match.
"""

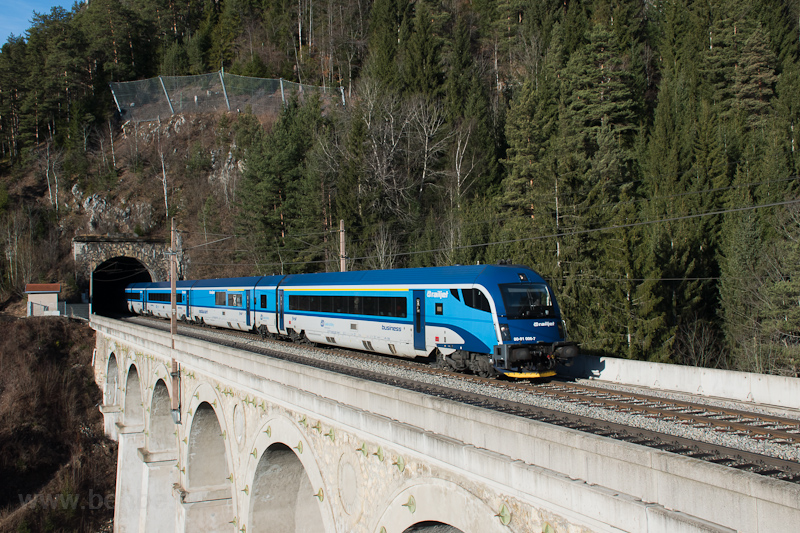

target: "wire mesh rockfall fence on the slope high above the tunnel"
[110,71,345,122]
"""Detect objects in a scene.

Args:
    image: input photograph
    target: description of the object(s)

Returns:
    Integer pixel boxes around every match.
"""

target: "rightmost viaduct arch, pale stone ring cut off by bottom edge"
[371,478,506,533]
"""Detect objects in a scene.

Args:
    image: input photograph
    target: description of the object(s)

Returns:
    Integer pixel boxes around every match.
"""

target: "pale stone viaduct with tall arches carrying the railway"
[92,316,800,533]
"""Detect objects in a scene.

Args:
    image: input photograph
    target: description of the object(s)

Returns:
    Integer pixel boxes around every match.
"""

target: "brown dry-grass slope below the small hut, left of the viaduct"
[0,318,117,531]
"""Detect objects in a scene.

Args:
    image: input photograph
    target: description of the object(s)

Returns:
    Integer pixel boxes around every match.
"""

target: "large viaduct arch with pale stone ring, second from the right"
[243,416,335,533]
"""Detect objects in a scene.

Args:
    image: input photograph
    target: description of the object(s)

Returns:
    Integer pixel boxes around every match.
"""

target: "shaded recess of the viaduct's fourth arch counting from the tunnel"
[186,401,230,490]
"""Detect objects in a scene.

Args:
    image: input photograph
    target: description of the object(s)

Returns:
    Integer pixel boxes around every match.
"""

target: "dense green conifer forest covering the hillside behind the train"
[0,0,800,376]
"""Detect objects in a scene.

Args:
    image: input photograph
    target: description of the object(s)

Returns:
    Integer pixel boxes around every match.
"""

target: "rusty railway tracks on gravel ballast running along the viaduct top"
[122,317,800,484]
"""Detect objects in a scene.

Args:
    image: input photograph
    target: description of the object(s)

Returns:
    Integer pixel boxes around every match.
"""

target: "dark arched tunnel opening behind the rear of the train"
[92,257,153,316]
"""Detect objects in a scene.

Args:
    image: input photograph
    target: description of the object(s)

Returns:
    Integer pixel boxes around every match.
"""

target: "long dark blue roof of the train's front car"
[281,265,544,287]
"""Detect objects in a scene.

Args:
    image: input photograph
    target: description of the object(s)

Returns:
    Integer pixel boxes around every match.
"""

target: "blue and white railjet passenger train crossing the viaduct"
[125,264,578,378]
